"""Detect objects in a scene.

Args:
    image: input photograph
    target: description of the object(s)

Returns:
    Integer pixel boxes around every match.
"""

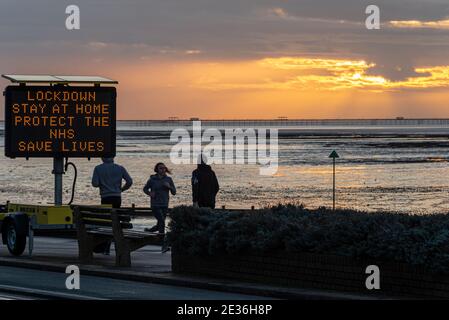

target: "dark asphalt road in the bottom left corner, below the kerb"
[0,266,272,300]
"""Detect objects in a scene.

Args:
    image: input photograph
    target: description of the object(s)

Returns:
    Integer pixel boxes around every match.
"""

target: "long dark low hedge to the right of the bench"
[168,205,449,273]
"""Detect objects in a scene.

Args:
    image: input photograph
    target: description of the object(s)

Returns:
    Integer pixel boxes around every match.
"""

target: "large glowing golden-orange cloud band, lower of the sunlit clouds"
[187,57,449,92]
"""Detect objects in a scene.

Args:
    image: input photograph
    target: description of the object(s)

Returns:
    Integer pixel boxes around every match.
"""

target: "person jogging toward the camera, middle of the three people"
[143,162,176,233]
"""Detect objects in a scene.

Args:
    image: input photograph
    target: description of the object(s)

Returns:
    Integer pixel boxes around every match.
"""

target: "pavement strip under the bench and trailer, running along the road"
[0,237,379,300]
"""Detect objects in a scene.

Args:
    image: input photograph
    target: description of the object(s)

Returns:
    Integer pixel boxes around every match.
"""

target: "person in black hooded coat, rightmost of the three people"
[192,154,220,209]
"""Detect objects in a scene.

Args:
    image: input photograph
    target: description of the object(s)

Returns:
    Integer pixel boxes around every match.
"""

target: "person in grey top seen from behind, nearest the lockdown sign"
[92,158,133,255]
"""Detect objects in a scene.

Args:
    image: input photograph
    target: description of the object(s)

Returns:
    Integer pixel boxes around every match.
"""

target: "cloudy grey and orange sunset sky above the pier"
[0,0,449,119]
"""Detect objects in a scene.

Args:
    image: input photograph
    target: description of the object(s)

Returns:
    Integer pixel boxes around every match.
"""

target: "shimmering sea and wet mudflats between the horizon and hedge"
[0,119,449,214]
